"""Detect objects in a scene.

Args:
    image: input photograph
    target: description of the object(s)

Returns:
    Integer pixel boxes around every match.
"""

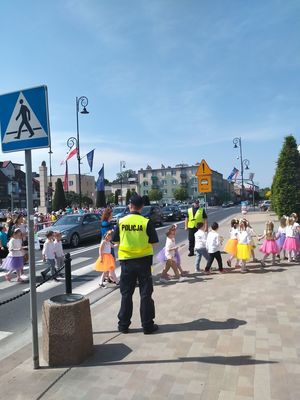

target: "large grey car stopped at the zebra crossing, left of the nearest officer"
[37,214,101,247]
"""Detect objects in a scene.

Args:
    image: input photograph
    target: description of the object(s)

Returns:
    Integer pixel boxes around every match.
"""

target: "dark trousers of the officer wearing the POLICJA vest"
[118,256,155,330]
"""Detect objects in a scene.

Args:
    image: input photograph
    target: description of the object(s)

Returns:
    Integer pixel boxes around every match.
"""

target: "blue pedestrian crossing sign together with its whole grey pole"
[0,86,50,369]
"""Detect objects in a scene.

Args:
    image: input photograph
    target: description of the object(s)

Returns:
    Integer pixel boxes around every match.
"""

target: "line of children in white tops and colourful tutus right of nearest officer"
[156,213,300,283]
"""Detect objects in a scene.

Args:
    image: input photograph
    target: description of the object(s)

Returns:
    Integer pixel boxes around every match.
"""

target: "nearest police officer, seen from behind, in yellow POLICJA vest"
[113,194,158,334]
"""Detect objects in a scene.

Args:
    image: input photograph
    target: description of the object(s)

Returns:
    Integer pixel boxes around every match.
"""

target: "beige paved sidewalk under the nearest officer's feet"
[0,212,300,400]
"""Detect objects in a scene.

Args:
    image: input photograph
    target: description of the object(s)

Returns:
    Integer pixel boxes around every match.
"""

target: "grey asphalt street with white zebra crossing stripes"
[0,207,239,359]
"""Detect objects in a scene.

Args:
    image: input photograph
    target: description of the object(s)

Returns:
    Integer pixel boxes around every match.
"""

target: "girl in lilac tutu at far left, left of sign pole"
[2,228,24,282]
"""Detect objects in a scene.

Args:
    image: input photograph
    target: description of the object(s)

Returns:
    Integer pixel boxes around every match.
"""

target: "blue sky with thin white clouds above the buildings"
[0,0,300,187]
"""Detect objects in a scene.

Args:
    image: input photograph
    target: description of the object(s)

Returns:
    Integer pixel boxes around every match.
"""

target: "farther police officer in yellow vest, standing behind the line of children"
[185,200,207,257]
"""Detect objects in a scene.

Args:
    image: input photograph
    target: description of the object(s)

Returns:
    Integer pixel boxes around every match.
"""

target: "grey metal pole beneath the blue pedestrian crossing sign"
[25,150,40,369]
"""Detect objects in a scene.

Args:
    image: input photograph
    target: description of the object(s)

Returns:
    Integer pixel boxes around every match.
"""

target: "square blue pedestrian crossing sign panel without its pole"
[0,86,50,153]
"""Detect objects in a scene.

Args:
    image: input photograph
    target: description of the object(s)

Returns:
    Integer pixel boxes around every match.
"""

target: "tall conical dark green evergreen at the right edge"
[271,135,300,217]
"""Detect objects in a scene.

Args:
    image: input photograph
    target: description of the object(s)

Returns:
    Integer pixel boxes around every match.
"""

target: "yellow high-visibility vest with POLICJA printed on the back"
[118,214,153,260]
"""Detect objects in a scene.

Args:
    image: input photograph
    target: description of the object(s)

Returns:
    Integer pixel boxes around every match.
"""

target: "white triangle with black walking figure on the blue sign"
[2,92,48,143]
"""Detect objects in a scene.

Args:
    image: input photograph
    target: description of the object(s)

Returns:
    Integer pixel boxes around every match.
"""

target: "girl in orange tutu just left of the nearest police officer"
[95,230,119,288]
